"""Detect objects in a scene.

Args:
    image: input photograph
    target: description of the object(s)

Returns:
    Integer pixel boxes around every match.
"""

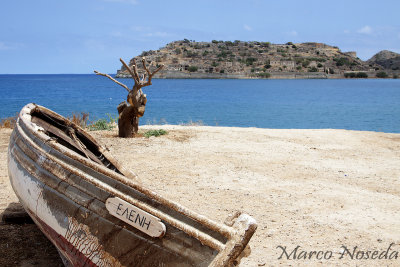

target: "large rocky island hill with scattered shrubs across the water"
[117,39,383,78]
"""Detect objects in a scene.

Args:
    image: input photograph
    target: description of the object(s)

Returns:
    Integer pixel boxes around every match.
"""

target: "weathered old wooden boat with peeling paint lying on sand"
[8,104,257,266]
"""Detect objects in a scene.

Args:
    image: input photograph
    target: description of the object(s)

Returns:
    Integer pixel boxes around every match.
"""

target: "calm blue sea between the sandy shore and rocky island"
[0,74,400,133]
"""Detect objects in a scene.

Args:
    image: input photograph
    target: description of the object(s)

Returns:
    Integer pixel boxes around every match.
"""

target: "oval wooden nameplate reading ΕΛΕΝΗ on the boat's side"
[106,197,166,237]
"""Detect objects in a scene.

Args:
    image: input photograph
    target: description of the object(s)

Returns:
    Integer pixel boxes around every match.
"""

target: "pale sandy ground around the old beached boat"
[0,125,400,266]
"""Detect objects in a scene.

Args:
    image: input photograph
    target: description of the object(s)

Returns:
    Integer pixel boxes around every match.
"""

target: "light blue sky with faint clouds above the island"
[0,0,400,74]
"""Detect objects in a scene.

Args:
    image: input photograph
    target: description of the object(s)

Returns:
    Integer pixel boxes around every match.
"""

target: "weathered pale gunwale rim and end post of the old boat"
[16,103,257,266]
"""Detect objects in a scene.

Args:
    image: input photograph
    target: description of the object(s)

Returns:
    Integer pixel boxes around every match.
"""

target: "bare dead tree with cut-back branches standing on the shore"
[94,57,164,137]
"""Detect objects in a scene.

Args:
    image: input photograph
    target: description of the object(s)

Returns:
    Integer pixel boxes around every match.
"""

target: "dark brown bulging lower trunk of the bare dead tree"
[117,101,139,138]
